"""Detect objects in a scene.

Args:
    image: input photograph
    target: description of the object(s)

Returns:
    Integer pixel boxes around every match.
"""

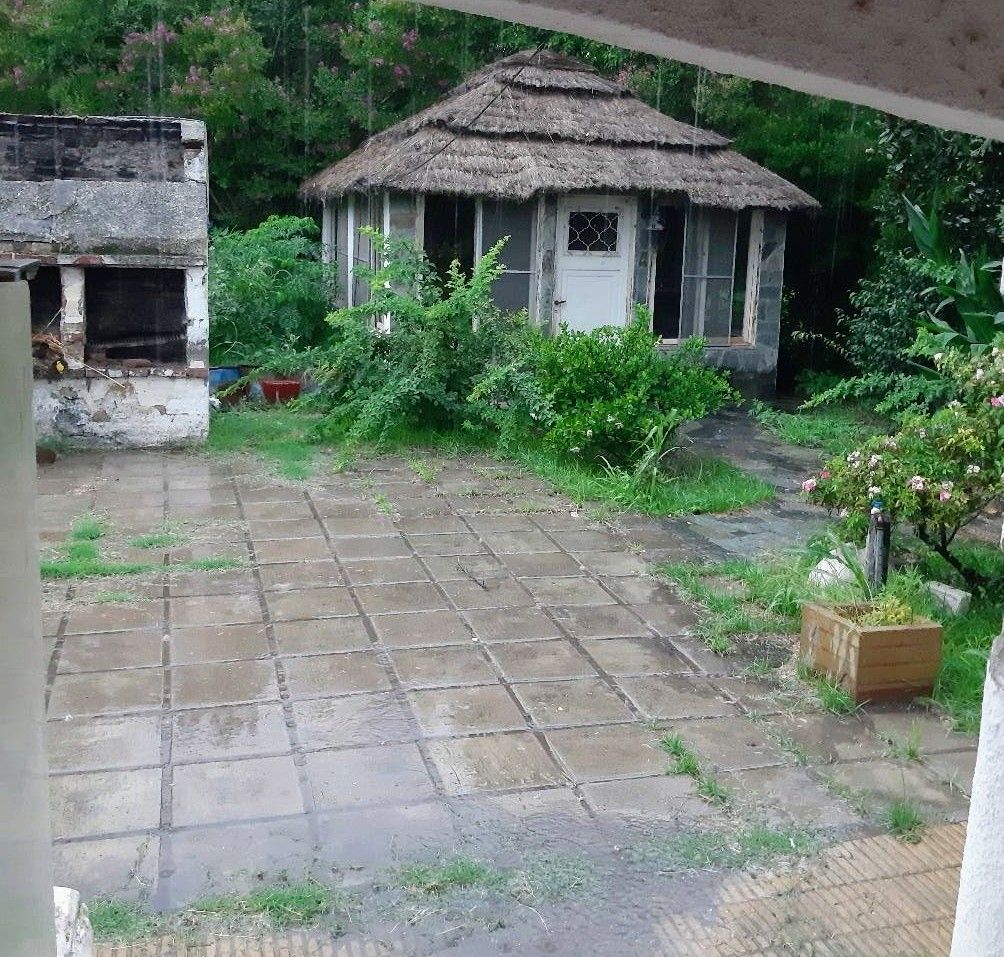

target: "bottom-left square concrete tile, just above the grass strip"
[52,833,161,902]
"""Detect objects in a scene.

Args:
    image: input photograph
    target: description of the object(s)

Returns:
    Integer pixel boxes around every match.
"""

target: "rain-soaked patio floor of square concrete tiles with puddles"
[40,415,975,954]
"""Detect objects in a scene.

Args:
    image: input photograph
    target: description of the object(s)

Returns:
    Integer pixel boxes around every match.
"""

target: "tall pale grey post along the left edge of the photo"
[0,263,56,957]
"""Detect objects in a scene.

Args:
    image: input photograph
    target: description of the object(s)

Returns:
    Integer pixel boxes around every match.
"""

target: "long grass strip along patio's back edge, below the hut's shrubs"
[207,408,774,515]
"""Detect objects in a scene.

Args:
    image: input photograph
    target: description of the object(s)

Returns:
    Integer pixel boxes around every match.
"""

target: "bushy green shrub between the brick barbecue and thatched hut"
[209,216,334,366]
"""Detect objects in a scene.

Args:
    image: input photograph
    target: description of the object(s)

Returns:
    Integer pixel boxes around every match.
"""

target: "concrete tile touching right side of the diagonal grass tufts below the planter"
[717,767,860,828]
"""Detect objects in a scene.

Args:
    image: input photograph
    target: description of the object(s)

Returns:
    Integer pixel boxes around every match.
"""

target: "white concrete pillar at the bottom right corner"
[952,634,1004,957]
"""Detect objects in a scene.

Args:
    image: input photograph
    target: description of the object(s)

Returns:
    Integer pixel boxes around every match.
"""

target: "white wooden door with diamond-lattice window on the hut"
[554,196,637,330]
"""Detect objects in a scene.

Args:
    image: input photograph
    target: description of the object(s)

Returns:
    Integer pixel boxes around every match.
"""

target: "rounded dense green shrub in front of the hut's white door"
[533,308,734,465]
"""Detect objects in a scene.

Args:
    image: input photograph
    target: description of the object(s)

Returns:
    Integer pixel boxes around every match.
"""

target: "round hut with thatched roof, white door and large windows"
[309,50,818,393]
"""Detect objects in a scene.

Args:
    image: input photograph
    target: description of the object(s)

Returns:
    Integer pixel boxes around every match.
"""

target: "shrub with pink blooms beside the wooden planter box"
[802,338,1004,587]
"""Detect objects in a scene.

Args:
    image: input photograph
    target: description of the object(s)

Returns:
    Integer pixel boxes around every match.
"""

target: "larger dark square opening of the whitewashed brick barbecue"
[83,266,187,365]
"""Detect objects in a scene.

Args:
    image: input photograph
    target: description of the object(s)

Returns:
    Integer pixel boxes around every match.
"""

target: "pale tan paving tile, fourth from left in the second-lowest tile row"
[428,732,565,794]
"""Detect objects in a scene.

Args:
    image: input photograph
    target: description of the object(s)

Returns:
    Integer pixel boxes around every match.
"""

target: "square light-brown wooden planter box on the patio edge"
[799,603,942,702]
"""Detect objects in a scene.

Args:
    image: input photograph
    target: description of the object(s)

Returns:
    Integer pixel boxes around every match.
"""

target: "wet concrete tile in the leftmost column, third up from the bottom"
[45,714,161,771]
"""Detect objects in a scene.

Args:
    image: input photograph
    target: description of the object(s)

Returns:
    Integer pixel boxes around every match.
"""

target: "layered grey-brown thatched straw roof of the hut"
[301,50,818,210]
